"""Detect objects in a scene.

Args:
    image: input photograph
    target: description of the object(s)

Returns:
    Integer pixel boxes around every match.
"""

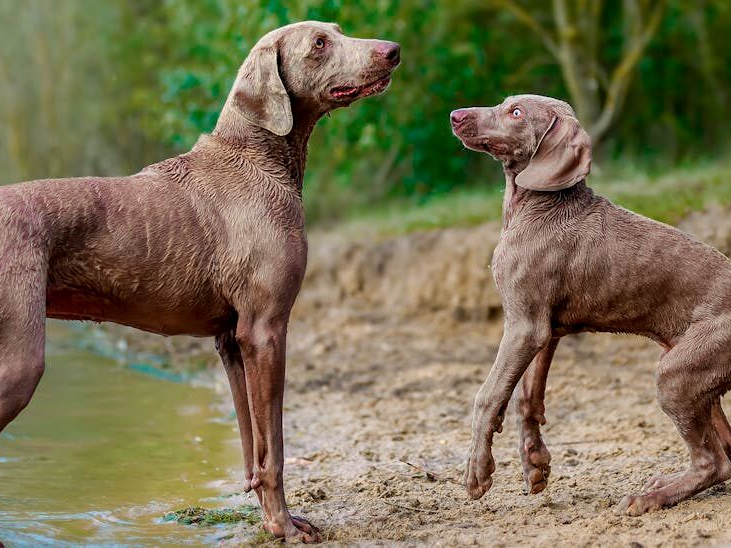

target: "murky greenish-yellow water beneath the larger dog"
[0,326,241,546]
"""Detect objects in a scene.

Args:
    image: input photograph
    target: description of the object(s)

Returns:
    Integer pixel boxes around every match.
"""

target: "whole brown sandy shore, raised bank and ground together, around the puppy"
[98,209,731,546]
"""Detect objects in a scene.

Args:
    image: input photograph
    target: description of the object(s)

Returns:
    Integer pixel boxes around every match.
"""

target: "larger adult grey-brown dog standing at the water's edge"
[0,22,400,541]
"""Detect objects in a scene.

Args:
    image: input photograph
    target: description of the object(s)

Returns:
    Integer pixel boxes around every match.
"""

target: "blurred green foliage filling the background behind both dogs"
[0,0,731,225]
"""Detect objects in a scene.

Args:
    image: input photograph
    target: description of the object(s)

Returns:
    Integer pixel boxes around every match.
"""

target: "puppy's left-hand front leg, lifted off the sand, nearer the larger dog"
[465,319,551,499]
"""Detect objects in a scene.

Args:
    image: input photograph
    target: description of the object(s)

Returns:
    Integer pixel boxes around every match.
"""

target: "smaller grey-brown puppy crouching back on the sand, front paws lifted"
[451,95,731,516]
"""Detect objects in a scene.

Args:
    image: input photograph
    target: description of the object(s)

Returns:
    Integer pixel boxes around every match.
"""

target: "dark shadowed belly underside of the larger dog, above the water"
[46,287,236,337]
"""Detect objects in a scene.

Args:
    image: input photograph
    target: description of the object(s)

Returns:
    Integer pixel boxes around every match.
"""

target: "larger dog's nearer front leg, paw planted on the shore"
[236,319,320,542]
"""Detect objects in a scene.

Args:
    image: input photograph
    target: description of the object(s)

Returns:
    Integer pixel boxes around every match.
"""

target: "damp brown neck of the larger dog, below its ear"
[211,101,324,196]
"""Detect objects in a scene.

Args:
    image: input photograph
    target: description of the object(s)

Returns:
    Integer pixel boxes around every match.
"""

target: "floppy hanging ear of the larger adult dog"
[233,42,293,135]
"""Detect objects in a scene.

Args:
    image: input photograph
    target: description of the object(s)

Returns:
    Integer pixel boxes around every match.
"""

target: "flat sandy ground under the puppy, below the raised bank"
[223,310,731,546]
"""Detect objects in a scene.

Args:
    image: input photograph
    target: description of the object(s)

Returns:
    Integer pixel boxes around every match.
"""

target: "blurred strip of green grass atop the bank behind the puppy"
[322,163,731,237]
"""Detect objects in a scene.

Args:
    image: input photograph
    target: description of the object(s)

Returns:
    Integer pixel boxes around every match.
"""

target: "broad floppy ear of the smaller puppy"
[515,116,591,191]
